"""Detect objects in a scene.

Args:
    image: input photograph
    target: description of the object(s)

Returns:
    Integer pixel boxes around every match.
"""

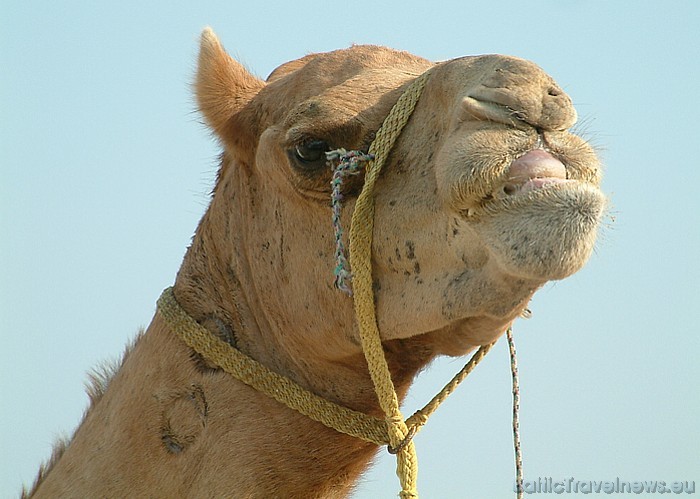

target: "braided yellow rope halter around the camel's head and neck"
[158,71,519,499]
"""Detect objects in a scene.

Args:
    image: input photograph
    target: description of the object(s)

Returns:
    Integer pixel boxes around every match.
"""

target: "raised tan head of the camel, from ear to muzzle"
[189,30,605,359]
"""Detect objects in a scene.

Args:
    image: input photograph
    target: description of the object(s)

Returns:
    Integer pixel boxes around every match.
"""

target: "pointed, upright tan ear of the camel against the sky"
[195,28,265,142]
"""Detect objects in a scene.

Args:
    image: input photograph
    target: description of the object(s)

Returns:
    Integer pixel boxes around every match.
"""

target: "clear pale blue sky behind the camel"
[0,0,700,499]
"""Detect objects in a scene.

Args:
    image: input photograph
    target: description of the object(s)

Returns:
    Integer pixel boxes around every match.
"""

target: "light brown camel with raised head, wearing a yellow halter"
[24,29,606,498]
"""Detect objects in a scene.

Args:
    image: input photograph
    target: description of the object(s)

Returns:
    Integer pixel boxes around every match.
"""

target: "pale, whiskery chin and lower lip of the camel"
[474,181,605,281]
